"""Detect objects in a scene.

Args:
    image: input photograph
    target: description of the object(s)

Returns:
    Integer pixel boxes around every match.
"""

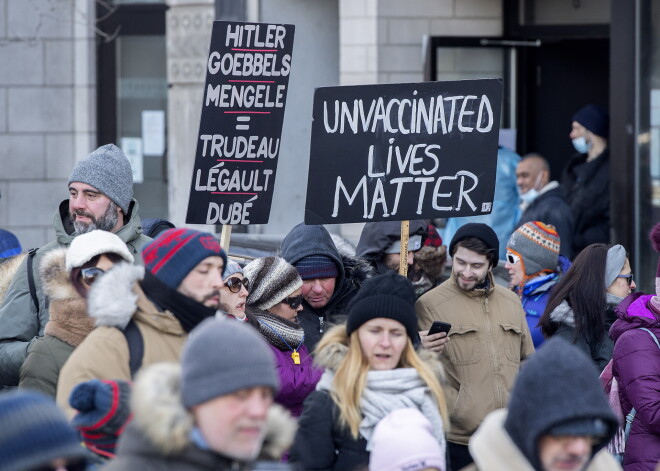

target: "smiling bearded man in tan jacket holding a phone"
[415,223,534,469]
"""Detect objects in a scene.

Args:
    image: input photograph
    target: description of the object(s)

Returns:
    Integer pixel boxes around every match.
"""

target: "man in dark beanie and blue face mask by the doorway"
[561,105,610,254]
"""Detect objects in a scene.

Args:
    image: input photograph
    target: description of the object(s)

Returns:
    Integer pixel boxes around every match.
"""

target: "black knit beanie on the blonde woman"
[346,270,418,342]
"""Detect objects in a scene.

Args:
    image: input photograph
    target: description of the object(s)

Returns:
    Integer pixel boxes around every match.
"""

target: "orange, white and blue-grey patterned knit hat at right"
[506,221,560,277]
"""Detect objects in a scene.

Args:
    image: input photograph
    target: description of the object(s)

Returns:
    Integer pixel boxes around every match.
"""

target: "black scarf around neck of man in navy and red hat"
[140,270,216,333]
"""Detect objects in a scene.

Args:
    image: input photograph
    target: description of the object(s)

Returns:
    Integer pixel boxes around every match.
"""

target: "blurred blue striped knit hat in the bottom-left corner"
[0,390,86,471]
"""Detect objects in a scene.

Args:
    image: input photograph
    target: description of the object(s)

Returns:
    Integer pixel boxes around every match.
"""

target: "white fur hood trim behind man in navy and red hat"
[87,262,144,329]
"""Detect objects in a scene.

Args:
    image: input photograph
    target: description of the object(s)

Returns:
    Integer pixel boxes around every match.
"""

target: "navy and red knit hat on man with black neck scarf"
[142,228,227,289]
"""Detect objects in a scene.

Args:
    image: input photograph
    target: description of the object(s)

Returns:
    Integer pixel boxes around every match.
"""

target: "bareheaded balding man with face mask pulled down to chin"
[516,153,573,259]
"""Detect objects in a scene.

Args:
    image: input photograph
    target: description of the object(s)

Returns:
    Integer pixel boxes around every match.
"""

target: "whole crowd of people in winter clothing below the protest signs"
[0,106,660,471]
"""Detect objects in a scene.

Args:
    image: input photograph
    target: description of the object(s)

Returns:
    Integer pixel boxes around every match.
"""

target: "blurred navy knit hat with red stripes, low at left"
[69,379,132,458]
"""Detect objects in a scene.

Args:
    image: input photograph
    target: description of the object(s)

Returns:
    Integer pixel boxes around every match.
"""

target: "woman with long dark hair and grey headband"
[539,244,635,371]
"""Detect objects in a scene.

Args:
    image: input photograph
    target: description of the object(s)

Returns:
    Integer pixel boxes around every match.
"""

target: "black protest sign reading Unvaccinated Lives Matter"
[305,79,502,224]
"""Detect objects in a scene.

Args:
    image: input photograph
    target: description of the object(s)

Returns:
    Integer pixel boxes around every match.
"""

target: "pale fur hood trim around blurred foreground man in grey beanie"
[131,363,297,460]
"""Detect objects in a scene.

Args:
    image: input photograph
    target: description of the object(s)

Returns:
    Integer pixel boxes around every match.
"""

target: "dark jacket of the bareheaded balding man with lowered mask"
[516,182,573,259]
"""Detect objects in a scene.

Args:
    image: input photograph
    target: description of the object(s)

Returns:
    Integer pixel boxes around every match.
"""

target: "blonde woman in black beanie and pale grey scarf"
[290,272,448,471]
